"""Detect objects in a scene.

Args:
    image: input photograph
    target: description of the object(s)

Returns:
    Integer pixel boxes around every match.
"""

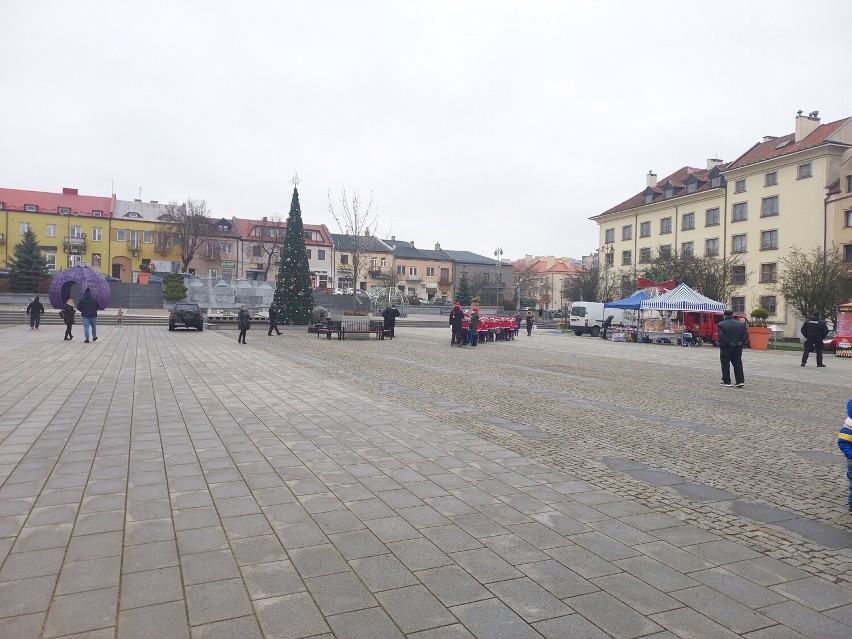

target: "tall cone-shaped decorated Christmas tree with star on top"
[272,185,314,326]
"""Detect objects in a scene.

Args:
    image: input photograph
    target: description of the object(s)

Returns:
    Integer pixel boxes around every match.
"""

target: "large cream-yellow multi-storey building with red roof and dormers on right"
[591,112,852,337]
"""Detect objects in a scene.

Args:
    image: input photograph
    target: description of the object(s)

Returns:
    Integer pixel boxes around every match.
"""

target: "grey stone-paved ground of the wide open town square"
[0,323,852,639]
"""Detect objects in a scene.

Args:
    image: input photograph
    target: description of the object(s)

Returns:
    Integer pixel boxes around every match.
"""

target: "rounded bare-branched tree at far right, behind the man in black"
[778,246,852,325]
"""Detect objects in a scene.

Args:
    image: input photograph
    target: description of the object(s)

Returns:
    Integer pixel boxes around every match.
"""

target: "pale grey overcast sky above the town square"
[0,0,852,259]
